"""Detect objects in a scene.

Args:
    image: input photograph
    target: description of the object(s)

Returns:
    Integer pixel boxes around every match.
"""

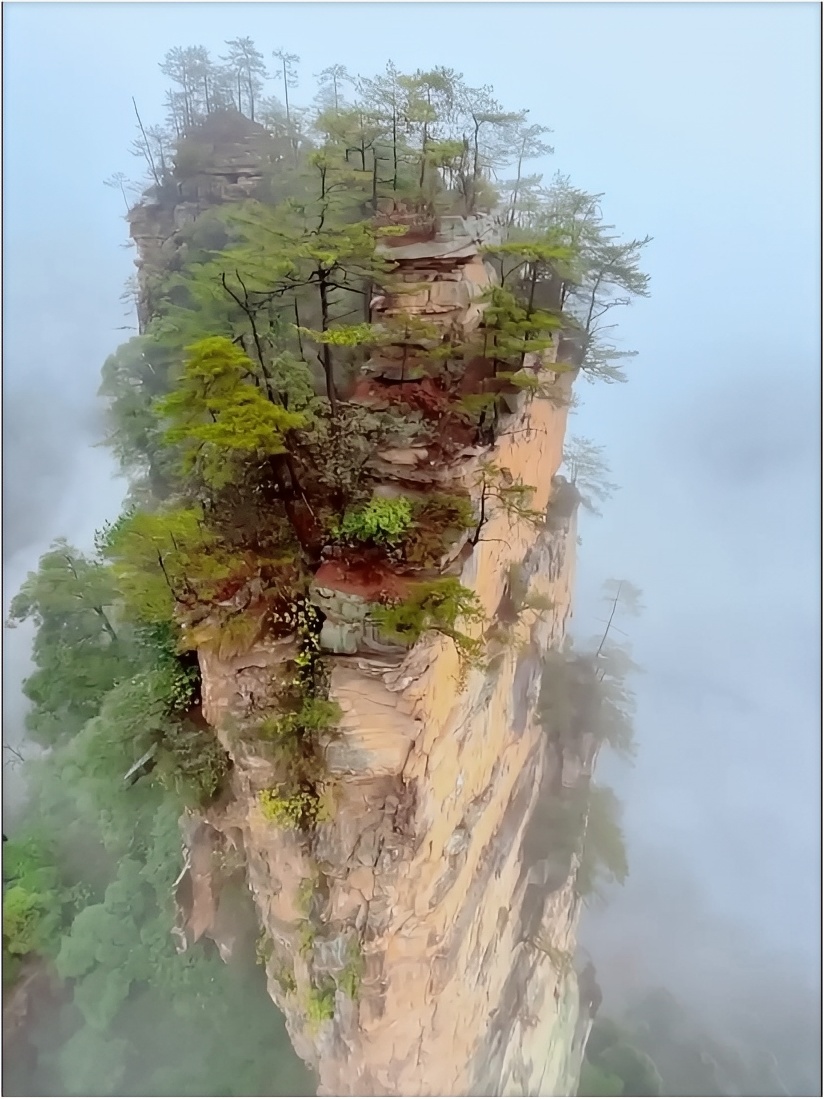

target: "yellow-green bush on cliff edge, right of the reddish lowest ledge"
[372,577,483,658]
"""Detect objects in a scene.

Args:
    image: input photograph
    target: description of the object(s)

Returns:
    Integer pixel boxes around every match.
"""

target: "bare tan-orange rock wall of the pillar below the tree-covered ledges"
[180,382,586,1095]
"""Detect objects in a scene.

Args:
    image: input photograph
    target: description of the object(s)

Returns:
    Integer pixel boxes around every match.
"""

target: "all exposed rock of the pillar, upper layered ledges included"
[132,118,591,1096]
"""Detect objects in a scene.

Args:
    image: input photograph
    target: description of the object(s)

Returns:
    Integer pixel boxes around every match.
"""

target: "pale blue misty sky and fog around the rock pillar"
[3,3,821,1081]
